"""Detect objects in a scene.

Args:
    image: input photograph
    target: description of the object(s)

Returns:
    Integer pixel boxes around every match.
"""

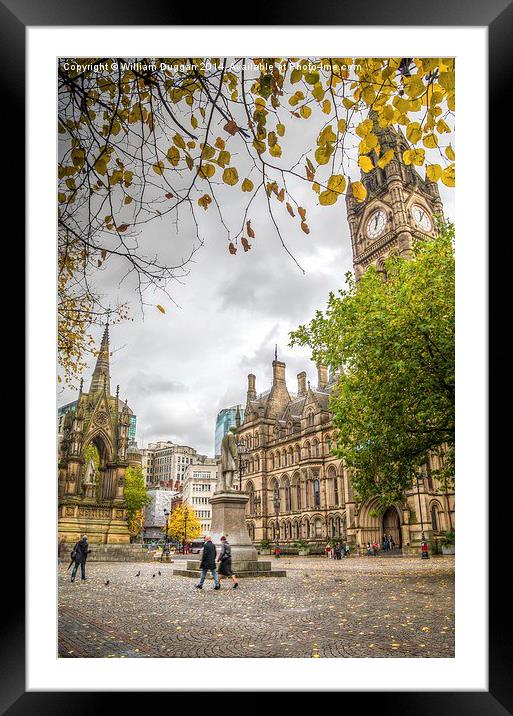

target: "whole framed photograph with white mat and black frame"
[7,2,504,714]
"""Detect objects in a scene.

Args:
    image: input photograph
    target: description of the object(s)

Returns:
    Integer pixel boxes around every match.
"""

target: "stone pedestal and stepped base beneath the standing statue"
[173,490,287,578]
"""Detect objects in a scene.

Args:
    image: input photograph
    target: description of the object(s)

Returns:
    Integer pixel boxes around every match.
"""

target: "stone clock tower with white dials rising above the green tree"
[346,112,443,279]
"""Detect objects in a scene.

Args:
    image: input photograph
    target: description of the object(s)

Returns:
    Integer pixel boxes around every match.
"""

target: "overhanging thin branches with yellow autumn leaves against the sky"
[58,57,455,381]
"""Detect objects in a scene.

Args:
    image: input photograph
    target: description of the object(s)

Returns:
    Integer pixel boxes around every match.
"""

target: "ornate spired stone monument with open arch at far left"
[58,325,132,544]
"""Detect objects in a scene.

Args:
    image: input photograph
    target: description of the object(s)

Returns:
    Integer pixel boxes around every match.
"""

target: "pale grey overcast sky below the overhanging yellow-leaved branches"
[58,61,453,455]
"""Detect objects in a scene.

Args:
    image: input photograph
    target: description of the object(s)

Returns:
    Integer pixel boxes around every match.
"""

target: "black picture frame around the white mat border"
[10,0,506,716]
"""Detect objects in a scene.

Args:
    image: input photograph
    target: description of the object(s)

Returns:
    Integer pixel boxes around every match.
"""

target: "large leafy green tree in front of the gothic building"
[291,225,455,505]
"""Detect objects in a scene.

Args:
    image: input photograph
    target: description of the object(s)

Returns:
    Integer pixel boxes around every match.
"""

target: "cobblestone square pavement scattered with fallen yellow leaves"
[59,557,454,658]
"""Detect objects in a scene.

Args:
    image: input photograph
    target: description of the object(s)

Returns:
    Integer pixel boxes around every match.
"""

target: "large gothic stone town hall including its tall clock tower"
[237,120,454,551]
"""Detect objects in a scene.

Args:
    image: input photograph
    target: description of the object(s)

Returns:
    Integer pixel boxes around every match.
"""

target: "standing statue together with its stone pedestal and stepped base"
[173,429,286,577]
